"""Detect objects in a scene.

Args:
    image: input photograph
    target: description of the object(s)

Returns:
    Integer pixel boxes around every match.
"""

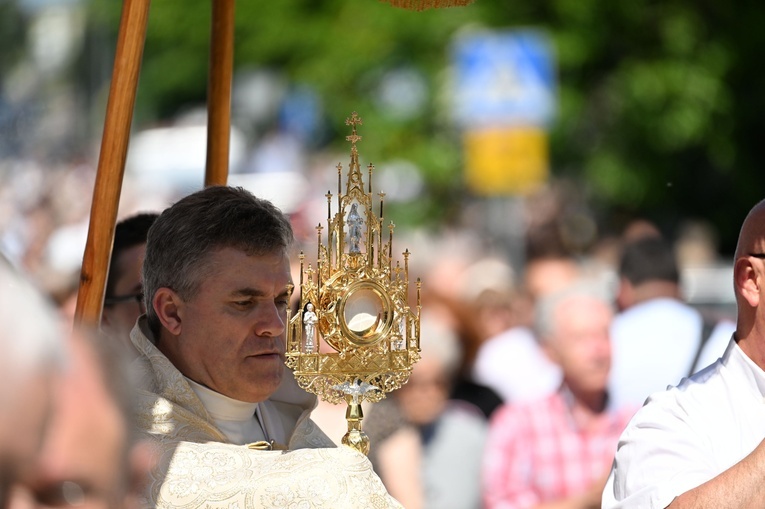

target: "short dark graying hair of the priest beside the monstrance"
[143,186,294,334]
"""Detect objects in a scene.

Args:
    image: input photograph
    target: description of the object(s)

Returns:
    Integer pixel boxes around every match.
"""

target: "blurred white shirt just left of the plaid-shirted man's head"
[472,327,562,403]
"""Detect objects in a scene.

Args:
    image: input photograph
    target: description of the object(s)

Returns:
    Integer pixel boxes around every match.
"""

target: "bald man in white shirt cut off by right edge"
[602,200,765,509]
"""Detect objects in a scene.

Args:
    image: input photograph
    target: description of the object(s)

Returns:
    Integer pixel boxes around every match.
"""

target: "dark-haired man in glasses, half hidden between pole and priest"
[101,212,159,352]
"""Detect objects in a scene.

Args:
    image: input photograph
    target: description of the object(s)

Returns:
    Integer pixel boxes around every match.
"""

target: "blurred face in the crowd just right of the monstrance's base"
[396,357,449,425]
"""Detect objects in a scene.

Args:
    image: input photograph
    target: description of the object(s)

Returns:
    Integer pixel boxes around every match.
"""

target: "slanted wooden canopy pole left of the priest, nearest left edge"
[74,0,150,327]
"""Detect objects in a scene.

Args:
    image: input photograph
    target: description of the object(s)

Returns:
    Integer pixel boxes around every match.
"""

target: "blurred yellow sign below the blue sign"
[464,127,549,196]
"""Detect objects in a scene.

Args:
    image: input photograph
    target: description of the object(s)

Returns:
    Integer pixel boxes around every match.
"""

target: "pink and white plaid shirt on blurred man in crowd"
[483,387,636,509]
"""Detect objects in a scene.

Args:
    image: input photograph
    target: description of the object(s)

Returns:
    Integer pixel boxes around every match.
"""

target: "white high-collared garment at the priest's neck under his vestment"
[184,377,268,445]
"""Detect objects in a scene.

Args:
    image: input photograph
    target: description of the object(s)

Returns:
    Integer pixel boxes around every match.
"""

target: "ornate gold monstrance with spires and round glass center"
[287,112,421,454]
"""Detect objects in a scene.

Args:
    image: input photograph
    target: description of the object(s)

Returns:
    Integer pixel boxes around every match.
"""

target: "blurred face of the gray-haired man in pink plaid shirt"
[547,297,612,392]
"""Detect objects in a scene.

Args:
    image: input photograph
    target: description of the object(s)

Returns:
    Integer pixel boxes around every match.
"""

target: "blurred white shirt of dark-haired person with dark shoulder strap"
[608,298,736,408]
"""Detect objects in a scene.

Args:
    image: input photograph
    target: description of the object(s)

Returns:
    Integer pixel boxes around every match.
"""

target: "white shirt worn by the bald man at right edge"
[602,340,765,509]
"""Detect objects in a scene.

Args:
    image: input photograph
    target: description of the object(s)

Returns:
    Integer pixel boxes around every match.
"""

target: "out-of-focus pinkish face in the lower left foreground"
[10,334,127,509]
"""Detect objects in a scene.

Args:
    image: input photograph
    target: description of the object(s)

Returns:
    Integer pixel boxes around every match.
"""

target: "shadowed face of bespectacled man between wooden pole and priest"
[102,244,146,343]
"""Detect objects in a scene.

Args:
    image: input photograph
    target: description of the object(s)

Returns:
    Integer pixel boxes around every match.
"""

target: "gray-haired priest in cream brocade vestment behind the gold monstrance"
[131,186,401,509]
